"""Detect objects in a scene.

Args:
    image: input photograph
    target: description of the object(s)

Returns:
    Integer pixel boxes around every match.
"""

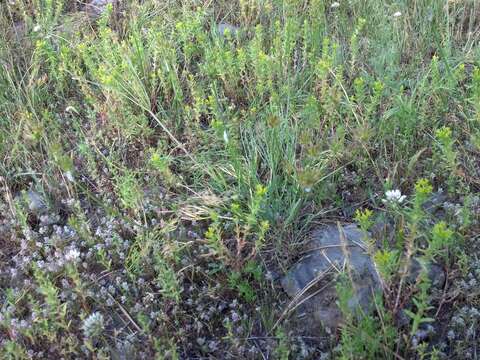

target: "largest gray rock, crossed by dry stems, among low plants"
[281,224,382,332]
